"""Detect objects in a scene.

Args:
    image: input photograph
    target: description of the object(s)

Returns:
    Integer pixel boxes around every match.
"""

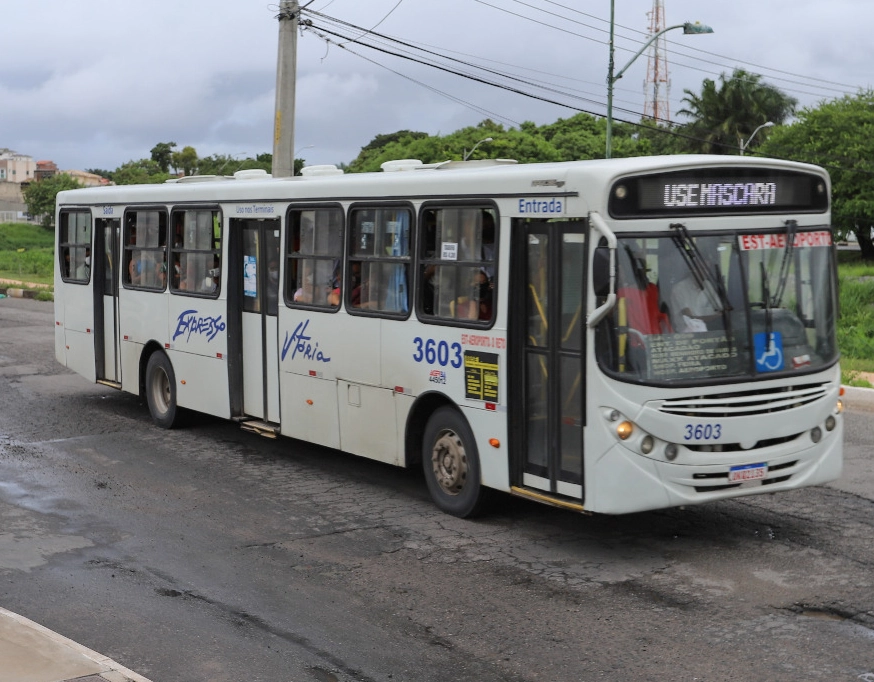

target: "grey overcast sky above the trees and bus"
[0,0,874,170]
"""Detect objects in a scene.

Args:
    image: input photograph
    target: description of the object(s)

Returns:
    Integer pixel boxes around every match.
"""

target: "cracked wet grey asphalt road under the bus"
[0,299,874,682]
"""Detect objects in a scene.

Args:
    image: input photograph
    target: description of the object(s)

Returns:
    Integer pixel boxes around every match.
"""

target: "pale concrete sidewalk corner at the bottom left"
[0,608,149,682]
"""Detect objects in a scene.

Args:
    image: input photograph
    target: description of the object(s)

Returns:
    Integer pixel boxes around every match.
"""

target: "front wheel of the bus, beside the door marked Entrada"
[422,407,485,518]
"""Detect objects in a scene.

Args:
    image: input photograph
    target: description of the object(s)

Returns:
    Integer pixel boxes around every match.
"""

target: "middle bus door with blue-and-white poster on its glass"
[231,219,280,424]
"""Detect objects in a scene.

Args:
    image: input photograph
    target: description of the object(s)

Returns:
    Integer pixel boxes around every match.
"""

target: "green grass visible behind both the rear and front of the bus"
[0,223,874,386]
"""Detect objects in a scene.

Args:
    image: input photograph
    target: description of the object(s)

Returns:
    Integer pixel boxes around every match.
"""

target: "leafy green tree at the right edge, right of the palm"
[760,90,874,260]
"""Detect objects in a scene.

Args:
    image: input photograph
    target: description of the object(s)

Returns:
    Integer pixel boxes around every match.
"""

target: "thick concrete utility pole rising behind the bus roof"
[273,0,300,178]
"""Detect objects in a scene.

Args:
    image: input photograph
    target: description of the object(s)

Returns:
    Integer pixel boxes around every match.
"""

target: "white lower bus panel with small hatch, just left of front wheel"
[337,381,403,466]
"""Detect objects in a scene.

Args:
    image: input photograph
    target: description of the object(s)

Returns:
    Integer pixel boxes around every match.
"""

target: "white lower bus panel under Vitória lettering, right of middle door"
[280,372,340,448]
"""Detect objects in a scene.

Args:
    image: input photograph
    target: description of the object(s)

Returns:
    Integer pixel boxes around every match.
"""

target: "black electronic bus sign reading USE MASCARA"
[610,168,828,218]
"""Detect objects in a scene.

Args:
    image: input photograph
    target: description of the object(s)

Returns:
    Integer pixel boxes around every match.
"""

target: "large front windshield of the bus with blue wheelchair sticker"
[597,221,838,384]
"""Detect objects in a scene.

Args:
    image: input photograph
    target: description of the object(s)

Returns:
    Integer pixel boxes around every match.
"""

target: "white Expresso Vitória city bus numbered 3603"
[55,156,843,516]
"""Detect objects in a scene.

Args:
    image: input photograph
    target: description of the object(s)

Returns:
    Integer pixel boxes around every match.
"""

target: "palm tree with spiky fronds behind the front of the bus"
[678,69,798,154]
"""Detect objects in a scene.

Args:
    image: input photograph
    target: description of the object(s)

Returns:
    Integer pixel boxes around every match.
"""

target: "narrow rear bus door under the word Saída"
[92,218,121,388]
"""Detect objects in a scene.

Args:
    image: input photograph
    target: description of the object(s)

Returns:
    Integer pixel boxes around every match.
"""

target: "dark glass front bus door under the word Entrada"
[510,219,586,505]
